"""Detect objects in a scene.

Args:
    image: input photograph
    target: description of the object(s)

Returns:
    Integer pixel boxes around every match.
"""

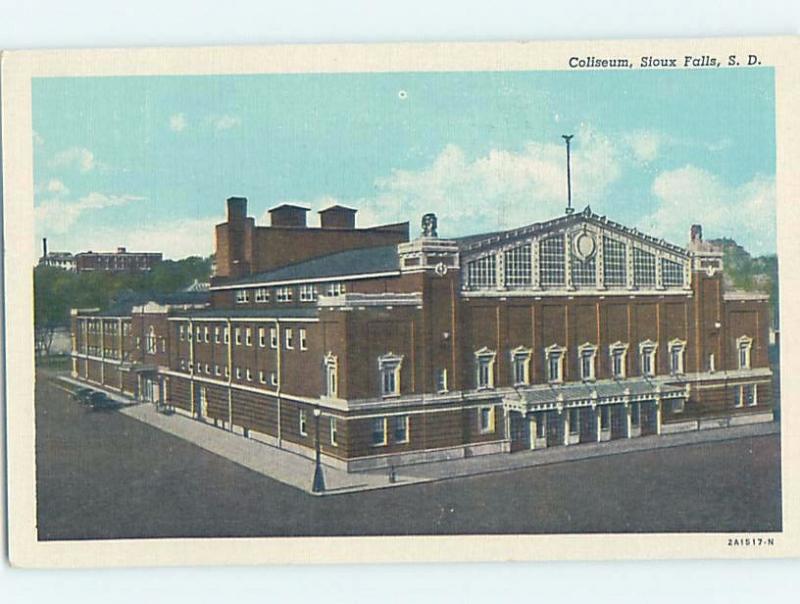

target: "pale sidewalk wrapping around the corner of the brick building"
[59,377,780,495]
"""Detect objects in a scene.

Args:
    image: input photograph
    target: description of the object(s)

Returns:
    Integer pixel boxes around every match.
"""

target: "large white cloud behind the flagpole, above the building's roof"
[272,127,621,237]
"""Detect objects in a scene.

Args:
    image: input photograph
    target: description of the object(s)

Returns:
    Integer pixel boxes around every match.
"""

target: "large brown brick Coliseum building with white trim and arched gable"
[72,198,772,470]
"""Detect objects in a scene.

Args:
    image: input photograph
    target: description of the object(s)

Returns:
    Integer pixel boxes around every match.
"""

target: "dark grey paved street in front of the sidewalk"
[36,380,781,539]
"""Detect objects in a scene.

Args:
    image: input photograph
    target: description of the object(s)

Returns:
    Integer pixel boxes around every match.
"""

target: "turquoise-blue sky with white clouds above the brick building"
[33,68,776,258]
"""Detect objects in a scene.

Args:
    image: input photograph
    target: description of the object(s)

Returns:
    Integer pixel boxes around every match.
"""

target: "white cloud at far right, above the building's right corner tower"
[639,165,776,254]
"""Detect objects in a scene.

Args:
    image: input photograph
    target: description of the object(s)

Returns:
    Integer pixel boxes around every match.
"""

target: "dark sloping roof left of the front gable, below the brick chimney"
[224,245,400,286]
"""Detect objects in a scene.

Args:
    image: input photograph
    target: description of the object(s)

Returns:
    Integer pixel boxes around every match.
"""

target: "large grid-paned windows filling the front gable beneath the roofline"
[467,235,684,289]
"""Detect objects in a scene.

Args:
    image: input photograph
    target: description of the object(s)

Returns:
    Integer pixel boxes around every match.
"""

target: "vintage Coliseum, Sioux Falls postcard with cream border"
[2,38,800,566]
